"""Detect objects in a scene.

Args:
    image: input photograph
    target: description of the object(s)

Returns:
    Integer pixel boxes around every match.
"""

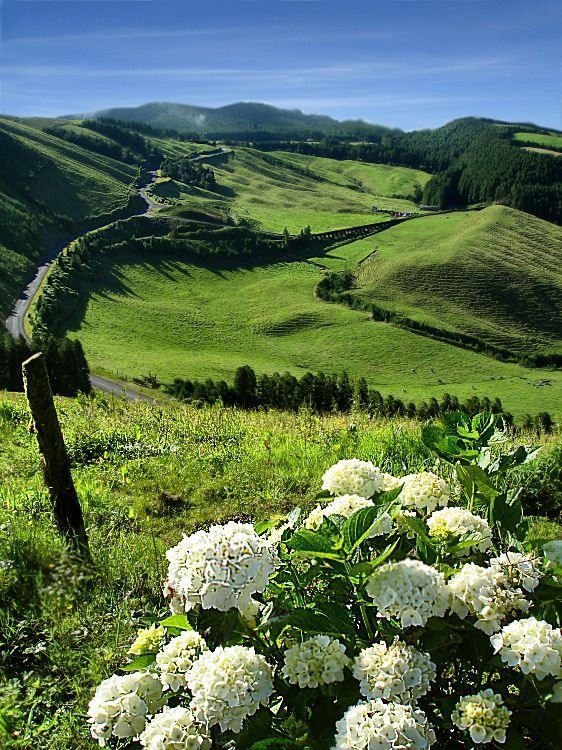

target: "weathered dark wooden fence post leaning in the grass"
[22,352,90,558]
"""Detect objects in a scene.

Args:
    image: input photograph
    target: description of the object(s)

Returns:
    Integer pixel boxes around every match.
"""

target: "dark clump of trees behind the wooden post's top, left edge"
[0,332,91,396]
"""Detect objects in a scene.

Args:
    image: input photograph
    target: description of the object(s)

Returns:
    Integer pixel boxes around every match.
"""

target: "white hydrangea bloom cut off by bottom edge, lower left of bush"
[140,706,212,750]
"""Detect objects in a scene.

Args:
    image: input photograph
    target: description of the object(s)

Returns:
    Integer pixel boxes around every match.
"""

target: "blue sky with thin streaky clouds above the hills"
[0,0,562,130]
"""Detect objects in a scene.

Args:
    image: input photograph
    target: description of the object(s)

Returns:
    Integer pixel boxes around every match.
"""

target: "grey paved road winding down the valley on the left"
[6,172,159,404]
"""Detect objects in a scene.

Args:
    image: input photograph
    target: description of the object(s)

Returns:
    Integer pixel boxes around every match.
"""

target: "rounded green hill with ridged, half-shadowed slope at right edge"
[357,206,562,353]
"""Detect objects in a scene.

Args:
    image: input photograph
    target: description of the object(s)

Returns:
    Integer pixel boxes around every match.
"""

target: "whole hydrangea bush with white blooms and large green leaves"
[89,414,562,750]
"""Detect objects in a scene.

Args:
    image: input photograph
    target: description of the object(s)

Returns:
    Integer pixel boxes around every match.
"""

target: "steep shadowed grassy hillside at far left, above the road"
[0,118,138,319]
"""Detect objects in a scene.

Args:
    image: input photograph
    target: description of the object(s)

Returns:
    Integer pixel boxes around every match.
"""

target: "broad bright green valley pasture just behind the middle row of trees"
[58,236,562,416]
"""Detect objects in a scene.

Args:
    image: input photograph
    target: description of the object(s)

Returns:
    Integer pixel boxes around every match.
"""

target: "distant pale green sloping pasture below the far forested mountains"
[147,144,430,233]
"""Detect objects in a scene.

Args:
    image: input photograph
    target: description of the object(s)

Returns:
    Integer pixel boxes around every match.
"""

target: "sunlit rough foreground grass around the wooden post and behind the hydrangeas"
[0,395,562,750]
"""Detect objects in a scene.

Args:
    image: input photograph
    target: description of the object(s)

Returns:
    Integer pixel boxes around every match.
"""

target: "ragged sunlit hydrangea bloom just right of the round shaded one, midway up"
[448,563,530,635]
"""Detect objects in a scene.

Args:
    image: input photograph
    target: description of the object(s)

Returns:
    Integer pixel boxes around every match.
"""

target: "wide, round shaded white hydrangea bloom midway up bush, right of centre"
[367,558,449,628]
